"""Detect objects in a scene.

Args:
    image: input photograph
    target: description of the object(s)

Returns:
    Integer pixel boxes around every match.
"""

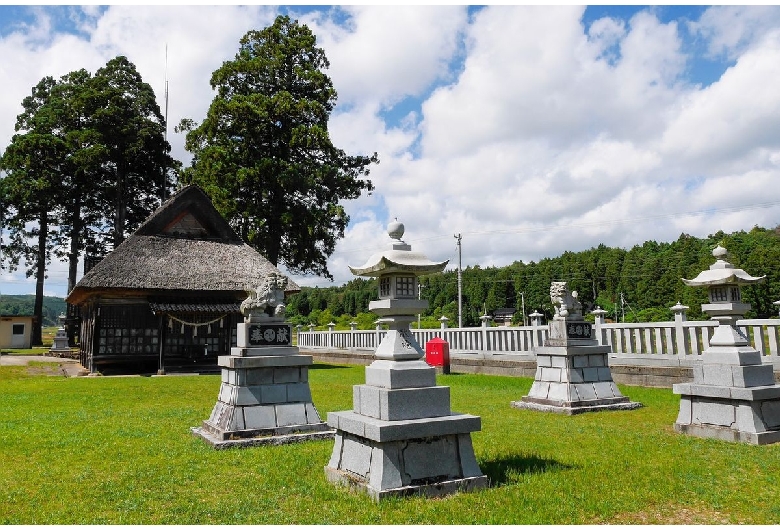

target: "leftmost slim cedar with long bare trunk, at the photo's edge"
[0,77,65,346]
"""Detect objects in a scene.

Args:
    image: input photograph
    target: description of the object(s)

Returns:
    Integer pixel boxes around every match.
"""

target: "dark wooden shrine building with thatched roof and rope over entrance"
[66,186,300,371]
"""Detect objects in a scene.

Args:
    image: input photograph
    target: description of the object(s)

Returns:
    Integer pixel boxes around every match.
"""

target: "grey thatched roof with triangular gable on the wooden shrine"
[67,186,300,304]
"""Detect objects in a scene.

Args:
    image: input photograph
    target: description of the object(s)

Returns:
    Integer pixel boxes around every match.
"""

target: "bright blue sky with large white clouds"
[0,5,780,296]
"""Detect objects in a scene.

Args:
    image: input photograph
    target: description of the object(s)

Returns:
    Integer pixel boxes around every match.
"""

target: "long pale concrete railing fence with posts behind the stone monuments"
[298,304,780,370]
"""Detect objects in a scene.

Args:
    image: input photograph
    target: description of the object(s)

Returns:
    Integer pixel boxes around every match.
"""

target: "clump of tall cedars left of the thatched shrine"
[0,56,175,345]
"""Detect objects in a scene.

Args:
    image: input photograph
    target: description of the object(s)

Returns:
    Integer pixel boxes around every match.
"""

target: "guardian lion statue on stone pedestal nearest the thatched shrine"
[192,274,334,448]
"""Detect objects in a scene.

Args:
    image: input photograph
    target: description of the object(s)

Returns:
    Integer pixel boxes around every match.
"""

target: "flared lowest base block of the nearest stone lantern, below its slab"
[325,430,488,500]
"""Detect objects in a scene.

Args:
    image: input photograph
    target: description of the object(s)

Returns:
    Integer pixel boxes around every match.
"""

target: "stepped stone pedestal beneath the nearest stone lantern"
[325,360,488,500]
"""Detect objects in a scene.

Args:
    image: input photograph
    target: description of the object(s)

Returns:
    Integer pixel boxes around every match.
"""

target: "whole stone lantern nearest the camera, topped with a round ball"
[325,221,487,500]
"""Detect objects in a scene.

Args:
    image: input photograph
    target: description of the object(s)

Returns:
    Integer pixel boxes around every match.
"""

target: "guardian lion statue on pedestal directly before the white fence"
[511,282,642,415]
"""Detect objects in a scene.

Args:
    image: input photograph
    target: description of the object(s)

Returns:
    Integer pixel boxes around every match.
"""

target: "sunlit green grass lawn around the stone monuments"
[0,364,780,524]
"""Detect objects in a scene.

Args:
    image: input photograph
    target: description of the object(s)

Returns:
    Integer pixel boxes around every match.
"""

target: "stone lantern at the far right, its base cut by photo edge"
[673,245,780,445]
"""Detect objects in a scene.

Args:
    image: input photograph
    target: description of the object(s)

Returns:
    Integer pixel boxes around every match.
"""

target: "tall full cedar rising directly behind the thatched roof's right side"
[177,16,379,278]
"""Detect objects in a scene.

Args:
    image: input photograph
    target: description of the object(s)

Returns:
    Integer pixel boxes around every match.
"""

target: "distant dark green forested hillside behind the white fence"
[287,227,780,329]
